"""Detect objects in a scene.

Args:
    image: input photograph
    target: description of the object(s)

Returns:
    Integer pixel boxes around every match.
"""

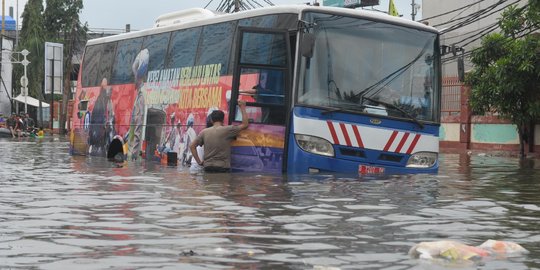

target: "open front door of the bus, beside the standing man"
[229,27,291,172]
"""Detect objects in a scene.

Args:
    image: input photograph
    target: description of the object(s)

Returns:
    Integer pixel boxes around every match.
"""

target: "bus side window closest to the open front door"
[196,22,236,75]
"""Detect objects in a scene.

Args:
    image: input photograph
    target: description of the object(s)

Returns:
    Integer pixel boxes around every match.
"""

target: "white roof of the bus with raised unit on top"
[87,5,439,45]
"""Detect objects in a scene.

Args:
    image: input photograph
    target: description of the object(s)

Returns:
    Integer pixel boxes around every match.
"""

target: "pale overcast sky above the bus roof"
[5,0,422,30]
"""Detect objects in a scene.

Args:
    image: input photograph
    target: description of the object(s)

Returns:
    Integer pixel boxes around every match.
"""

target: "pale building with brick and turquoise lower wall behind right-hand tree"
[422,0,540,152]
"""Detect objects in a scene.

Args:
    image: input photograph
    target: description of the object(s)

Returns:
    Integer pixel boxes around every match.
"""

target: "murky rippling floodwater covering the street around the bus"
[0,137,540,270]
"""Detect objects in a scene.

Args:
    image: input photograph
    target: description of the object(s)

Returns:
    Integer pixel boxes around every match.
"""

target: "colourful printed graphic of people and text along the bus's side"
[75,49,284,170]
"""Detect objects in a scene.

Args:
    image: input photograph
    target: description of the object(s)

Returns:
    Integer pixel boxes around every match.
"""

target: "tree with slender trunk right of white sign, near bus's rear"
[43,0,88,133]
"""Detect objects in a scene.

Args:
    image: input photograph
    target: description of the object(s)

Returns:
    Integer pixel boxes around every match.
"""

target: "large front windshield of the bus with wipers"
[297,12,440,121]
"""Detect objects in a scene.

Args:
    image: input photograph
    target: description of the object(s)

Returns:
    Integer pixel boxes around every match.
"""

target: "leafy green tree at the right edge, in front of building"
[466,0,540,157]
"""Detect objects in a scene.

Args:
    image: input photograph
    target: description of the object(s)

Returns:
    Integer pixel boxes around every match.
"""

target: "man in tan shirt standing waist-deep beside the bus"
[189,100,249,172]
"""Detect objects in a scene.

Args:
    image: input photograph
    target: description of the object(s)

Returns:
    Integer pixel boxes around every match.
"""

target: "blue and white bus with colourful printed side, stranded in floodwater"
[70,5,441,174]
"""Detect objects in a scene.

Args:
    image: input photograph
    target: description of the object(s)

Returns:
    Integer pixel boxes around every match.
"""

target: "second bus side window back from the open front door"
[167,27,202,68]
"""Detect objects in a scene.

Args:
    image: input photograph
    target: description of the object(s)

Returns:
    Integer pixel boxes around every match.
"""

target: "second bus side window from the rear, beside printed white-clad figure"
[110,38,142,84]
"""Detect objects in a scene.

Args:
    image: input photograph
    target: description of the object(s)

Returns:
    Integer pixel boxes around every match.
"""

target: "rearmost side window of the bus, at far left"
[82,43,116,87]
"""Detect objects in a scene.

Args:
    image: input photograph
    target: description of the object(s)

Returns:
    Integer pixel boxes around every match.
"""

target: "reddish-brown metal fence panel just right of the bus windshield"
[441,76,463,116]
